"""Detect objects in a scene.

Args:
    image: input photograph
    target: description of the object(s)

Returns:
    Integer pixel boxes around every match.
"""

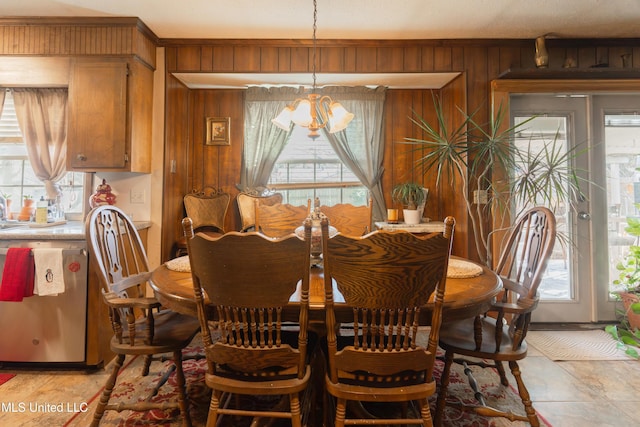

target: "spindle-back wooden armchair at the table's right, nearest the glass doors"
[435,206,556,426]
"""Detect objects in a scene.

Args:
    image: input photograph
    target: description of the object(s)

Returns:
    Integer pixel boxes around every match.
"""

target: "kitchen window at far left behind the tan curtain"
[0,92,87,219]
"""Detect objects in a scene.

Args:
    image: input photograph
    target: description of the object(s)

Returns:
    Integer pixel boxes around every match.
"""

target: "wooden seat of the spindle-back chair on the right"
[439,317,527,361]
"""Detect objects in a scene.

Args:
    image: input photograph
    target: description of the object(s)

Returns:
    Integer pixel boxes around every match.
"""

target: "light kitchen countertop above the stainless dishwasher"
[0,221,151,240]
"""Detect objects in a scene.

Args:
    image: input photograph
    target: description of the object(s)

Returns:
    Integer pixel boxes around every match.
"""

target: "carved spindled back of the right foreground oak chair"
[322,217,455,397]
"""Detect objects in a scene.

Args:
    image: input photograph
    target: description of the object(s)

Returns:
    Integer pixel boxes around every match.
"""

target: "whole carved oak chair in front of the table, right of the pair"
[321,217,455,427]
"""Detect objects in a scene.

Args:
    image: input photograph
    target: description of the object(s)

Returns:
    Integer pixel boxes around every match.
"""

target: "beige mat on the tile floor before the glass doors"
[527,329,632,360]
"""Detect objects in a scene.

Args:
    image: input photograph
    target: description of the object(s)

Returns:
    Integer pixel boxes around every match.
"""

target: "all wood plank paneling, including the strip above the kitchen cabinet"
[0,17,640,260]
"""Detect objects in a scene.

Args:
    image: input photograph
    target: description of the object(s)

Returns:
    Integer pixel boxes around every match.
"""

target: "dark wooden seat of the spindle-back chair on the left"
[111,310,200,354]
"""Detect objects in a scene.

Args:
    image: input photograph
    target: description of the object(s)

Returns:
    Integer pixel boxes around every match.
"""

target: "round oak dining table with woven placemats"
[151,257,502,324]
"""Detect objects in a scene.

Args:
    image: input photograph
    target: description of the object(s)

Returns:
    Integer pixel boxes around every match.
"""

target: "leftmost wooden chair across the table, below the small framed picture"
[176,187,230,256]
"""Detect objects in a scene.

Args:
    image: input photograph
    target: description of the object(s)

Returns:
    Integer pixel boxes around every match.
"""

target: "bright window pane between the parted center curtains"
[269,126,368,206]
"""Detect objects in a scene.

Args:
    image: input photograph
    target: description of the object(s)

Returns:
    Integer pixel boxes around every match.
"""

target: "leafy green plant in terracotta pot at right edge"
[605,209,640,359]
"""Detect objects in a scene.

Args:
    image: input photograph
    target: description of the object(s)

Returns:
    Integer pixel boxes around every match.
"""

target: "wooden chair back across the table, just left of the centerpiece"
[254,199,311,237]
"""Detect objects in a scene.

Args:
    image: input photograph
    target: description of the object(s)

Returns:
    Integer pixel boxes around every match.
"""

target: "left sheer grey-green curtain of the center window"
[238,87,304,193]
